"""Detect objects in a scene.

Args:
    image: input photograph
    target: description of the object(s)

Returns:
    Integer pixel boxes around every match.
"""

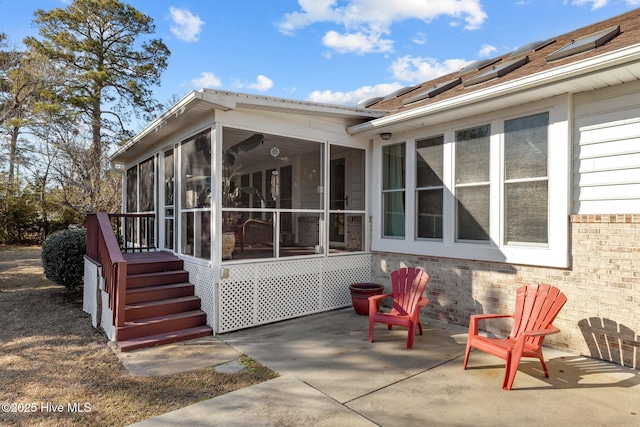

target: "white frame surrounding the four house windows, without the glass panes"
[371,96,571,268]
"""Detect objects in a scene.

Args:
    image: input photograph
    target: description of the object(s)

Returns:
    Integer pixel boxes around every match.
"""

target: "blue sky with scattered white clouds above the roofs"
[0,0,640,105]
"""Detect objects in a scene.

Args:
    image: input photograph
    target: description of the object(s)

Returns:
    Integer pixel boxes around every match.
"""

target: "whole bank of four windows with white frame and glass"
[371,102,571,268]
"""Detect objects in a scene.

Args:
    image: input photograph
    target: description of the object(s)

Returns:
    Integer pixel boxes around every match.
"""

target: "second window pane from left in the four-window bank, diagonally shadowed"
[416,135,444,239]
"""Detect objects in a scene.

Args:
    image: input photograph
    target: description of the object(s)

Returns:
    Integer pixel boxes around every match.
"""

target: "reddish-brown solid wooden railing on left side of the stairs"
[87,212,127,341]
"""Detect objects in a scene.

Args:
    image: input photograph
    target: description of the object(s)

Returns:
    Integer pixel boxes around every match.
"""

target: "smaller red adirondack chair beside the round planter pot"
[369,267,429,350]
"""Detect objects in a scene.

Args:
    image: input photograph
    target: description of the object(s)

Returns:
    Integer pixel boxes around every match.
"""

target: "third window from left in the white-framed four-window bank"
[455,125,491,242]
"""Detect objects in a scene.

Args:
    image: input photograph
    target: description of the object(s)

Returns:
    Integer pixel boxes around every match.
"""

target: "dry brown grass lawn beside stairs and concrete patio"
[0,247,276,426]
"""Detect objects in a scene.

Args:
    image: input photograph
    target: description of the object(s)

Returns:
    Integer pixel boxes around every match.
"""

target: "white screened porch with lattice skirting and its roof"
[85,90,384,348]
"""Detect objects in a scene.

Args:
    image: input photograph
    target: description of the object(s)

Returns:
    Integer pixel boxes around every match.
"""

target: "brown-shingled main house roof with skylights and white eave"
[347,9,640,136]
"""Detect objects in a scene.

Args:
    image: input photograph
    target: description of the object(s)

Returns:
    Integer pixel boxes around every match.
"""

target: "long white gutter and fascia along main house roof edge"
[347,45,640,135]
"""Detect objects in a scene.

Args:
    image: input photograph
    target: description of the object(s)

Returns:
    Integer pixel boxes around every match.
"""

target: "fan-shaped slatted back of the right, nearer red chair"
[509,284,567,345]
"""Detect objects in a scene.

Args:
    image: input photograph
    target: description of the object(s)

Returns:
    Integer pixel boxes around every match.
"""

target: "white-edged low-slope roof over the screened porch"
[109,89,387,164]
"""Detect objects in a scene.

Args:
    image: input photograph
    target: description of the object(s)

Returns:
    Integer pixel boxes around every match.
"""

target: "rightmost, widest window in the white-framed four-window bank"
[504,113,549,244]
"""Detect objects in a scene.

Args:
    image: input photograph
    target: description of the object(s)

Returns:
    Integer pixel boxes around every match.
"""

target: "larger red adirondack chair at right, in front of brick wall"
[464,285,567,390]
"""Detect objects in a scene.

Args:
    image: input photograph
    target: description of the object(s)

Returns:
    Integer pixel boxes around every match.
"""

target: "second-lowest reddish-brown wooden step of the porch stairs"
[116,310,207,342]
